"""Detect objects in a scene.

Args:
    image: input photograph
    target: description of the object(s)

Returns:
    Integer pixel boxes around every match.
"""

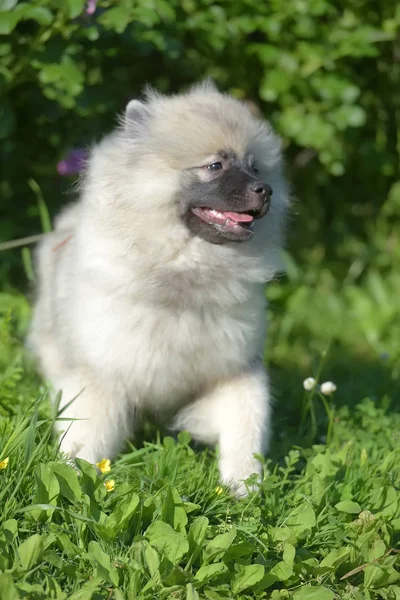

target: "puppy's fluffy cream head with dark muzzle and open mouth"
[88,83,286,250]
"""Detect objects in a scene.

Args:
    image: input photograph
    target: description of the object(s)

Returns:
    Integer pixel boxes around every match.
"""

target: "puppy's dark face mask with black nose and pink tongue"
[181,151,272,244]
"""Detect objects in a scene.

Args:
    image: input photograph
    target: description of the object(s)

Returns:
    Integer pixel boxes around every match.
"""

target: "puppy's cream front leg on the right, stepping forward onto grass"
[174,367,270,496]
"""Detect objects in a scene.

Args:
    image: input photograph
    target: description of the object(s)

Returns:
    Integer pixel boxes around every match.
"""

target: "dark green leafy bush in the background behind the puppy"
[0,0,400,370]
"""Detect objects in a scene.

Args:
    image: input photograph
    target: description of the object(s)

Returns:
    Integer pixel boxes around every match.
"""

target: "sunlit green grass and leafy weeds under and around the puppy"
[0,258,400,600]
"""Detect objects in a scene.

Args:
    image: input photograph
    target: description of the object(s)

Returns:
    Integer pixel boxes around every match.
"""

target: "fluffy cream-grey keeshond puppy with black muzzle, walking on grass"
[30,83,288,496]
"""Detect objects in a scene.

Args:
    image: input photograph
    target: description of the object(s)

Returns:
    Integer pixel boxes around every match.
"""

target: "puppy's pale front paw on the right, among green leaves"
[219,457,261,499]
